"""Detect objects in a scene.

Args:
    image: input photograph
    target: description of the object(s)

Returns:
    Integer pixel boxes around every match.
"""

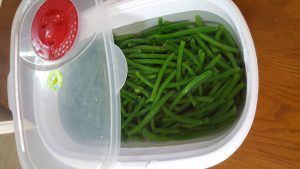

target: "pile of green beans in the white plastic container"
[114,15,246,142]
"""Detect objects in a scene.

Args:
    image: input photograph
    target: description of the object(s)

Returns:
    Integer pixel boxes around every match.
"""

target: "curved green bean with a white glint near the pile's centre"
[171,70,213,109]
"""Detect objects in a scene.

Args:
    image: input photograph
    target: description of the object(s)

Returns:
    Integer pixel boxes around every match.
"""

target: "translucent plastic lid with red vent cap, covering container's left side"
[9,0,127,169]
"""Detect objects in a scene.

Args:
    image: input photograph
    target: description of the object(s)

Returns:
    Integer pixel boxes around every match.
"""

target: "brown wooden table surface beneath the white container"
[0,0,300,169]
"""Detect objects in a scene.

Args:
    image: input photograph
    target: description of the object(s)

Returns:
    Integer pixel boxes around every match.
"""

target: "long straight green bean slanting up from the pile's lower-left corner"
[128,92,174,135]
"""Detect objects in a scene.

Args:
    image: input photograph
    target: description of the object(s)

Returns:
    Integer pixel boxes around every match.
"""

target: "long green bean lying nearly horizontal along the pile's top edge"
[148,26,217,39]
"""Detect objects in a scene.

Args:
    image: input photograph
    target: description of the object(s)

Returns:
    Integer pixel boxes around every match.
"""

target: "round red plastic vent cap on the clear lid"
[31,0,78,60]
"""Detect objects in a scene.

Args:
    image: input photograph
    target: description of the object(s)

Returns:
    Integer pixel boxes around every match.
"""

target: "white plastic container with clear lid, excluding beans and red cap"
[8,0,258,169]
